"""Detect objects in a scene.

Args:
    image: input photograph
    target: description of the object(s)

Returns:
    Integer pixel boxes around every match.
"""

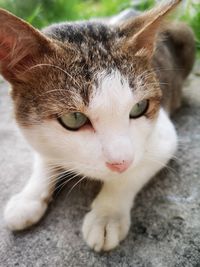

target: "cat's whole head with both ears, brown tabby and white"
[0,0,180,180]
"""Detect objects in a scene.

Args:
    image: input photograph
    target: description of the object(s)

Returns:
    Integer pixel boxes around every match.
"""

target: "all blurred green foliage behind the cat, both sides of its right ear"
[0,0,200,55]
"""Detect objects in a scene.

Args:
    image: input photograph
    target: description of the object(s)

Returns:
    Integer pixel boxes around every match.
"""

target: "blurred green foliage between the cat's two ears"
[0,0,132,28]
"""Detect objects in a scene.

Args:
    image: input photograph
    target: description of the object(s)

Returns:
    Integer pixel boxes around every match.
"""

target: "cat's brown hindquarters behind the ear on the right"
[152,22,195,114]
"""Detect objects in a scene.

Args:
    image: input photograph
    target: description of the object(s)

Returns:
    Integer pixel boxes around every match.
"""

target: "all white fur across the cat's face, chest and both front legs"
[5,71,177,251]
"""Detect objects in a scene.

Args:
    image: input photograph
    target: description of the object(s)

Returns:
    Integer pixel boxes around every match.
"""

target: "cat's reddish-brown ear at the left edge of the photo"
[0,9,51,79]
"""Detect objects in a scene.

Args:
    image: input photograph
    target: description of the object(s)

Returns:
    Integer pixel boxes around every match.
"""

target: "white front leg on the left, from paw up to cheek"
[4,155,56,231]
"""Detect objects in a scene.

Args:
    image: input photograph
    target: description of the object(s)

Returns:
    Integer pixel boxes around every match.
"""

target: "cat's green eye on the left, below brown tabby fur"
[58,112,88,131]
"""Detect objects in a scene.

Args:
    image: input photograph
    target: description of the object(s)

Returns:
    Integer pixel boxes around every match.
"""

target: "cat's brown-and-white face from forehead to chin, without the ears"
[9,25,161,180]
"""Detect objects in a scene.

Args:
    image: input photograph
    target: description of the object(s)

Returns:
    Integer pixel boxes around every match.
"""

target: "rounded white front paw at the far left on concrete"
[4,193,47,231]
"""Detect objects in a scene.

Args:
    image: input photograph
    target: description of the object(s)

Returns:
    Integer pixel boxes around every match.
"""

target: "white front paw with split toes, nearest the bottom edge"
[82,209,130,252]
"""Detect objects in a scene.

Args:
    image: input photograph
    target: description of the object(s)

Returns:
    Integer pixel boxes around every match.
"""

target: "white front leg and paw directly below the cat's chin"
[82,179,134,251]
